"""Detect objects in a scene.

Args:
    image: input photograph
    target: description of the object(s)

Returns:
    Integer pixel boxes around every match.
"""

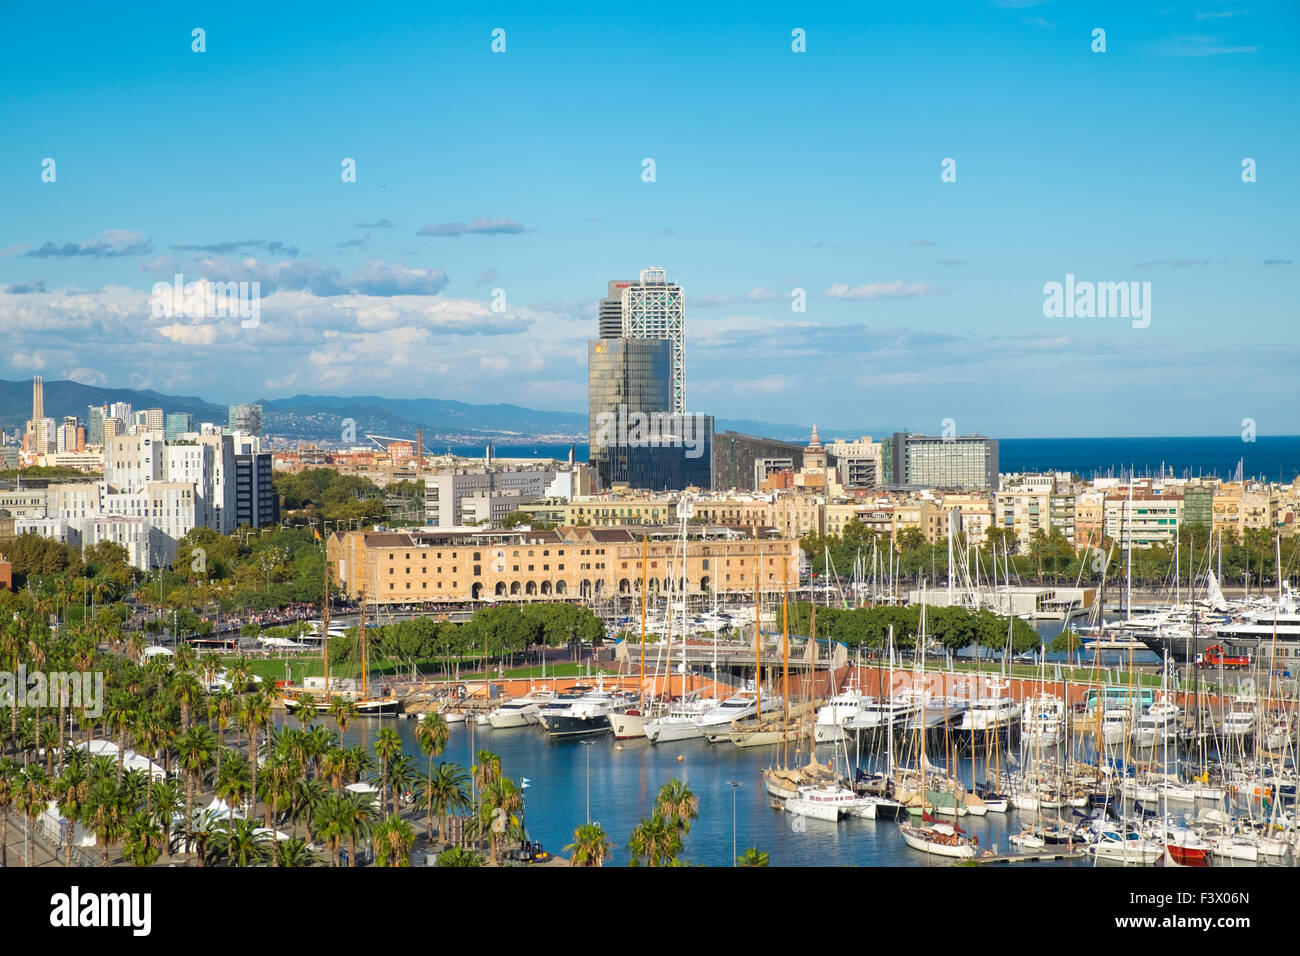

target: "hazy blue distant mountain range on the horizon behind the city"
[0,380,892,445]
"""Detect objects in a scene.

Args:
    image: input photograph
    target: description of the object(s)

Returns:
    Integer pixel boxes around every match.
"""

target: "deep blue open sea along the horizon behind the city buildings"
[449,434,1300,483]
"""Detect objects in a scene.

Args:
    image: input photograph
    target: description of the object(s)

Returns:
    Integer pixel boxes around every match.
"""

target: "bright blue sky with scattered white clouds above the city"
[0,0,1300,437]
